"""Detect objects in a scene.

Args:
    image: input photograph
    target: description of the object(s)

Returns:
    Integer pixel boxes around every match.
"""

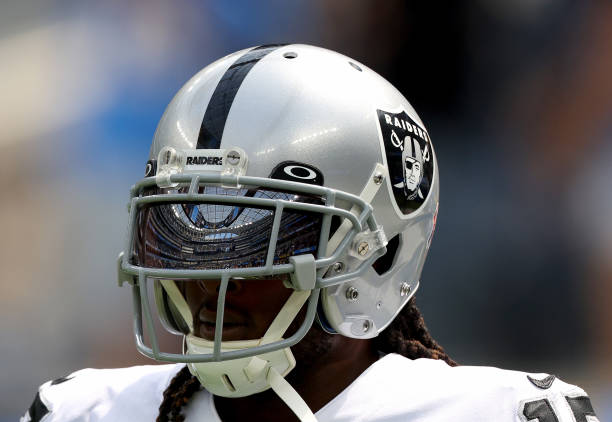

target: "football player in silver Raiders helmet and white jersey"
[22,45,596,422]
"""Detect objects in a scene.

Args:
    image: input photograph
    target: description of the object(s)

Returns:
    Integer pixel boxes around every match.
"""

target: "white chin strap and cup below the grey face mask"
[161,280,317,422]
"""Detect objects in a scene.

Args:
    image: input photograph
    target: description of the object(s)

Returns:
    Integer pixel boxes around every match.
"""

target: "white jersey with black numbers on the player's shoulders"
[21,354,597,422]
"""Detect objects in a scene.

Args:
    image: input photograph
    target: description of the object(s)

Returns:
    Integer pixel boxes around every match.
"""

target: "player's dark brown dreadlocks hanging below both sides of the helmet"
[157,297,457,422]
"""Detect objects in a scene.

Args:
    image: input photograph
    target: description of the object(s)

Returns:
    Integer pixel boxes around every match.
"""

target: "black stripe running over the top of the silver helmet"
[197,44,285,149]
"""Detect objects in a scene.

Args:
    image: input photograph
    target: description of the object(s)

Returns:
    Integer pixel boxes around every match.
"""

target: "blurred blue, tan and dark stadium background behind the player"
[0,0,612,422]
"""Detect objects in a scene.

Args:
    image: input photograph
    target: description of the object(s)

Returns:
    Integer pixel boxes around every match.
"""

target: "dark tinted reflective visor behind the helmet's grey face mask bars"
[132,186,323,269]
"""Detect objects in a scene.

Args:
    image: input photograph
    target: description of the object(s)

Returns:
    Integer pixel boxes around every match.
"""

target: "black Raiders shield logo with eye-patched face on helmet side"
[376,110,434,215]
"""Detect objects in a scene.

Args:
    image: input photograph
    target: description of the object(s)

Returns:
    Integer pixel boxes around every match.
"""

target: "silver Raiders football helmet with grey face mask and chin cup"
[118,44,439,416]
